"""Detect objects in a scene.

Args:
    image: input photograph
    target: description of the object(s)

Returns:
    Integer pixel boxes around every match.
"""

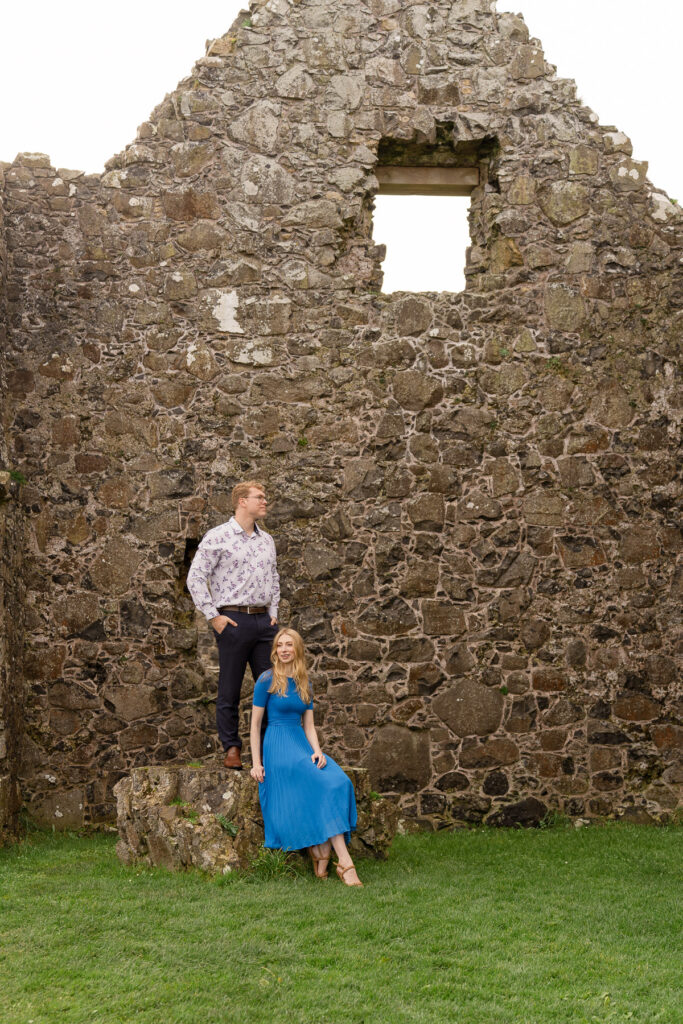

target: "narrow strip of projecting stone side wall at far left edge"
[0,169,25,842]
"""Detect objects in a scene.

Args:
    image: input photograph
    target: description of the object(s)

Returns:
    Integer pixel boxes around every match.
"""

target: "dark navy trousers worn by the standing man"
[214,611,278,751]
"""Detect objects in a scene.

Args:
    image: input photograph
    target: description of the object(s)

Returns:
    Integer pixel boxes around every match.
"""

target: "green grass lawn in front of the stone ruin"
[0,825,683,1024]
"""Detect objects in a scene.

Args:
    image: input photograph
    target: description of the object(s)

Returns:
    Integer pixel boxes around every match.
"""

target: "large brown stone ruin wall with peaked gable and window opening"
[4,0,683,827]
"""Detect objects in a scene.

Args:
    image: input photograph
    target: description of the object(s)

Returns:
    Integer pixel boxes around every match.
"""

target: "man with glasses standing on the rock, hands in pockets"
[187,480,280,770]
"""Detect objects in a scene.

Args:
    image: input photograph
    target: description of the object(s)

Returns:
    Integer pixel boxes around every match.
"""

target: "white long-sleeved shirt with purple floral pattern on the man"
[187,516,280,620]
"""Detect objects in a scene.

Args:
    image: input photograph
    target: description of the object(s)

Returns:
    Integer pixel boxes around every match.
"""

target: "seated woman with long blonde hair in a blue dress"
[250,629,362,886]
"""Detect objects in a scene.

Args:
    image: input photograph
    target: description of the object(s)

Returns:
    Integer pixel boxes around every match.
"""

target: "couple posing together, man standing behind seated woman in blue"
[187,480,361,886]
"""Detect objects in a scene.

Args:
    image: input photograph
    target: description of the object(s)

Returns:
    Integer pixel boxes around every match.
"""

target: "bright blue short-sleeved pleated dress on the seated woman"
[254,671,356,850]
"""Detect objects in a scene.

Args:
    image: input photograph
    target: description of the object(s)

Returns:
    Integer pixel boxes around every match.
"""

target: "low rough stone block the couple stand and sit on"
[114,763,398,873]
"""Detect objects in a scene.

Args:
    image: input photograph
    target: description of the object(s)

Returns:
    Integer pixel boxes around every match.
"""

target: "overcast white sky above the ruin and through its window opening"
[0,0,683,291]
